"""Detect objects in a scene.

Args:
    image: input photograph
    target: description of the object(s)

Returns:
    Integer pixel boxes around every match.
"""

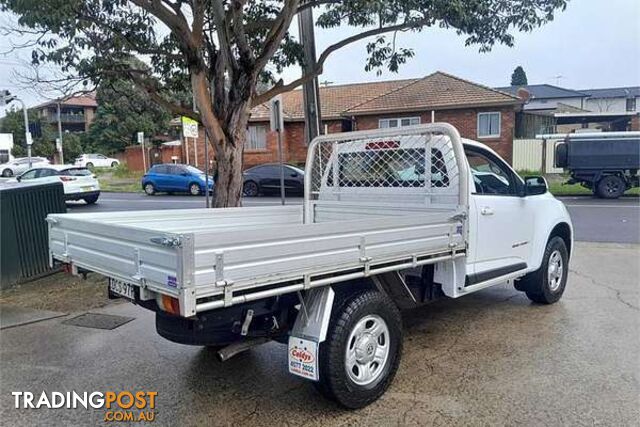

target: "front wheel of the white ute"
[516,236,569,304]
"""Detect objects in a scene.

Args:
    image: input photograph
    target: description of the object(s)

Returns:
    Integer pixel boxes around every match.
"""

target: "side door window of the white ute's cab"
[465,149,517,196]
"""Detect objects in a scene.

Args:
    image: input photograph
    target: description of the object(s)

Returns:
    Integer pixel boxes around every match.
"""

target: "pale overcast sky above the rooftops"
[0,0,640,116]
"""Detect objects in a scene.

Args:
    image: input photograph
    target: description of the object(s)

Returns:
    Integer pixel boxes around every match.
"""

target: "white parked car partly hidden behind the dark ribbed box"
[15,165,100,205]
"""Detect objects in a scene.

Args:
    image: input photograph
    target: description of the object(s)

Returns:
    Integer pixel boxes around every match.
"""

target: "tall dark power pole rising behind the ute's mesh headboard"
[298,7,322,144]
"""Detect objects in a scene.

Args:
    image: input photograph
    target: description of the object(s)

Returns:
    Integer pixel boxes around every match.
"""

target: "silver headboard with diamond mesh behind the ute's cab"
[310,130,459,203]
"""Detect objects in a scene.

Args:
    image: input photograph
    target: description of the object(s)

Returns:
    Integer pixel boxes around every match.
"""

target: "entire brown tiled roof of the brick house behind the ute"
[251,72,521,121]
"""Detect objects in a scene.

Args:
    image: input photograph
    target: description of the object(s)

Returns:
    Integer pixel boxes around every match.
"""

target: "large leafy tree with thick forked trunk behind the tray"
[0,0,566,206]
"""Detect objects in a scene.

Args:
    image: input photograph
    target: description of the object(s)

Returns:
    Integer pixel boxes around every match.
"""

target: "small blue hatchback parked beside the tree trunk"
[142,163,214,196]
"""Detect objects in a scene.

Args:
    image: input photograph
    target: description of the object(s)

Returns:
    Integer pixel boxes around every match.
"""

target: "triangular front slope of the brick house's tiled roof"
[345,71,522,114]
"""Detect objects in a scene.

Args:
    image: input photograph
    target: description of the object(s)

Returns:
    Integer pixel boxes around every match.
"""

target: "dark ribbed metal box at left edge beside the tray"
[0,182,67,289]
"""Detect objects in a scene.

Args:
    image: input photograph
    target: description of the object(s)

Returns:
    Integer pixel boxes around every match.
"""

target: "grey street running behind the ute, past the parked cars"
[67,193,640,243]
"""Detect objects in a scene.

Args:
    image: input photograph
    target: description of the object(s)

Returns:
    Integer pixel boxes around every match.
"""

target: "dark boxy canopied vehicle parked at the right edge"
[555,132,640,199]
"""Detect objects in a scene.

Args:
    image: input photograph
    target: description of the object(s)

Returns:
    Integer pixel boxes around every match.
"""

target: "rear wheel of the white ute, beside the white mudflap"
[316,290,402,409]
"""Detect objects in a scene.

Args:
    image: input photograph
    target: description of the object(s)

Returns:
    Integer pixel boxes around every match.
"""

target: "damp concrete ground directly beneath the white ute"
[0,243,640,427]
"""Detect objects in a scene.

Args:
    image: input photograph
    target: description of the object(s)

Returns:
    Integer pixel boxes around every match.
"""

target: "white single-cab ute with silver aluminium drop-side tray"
[47,123,573,408]
